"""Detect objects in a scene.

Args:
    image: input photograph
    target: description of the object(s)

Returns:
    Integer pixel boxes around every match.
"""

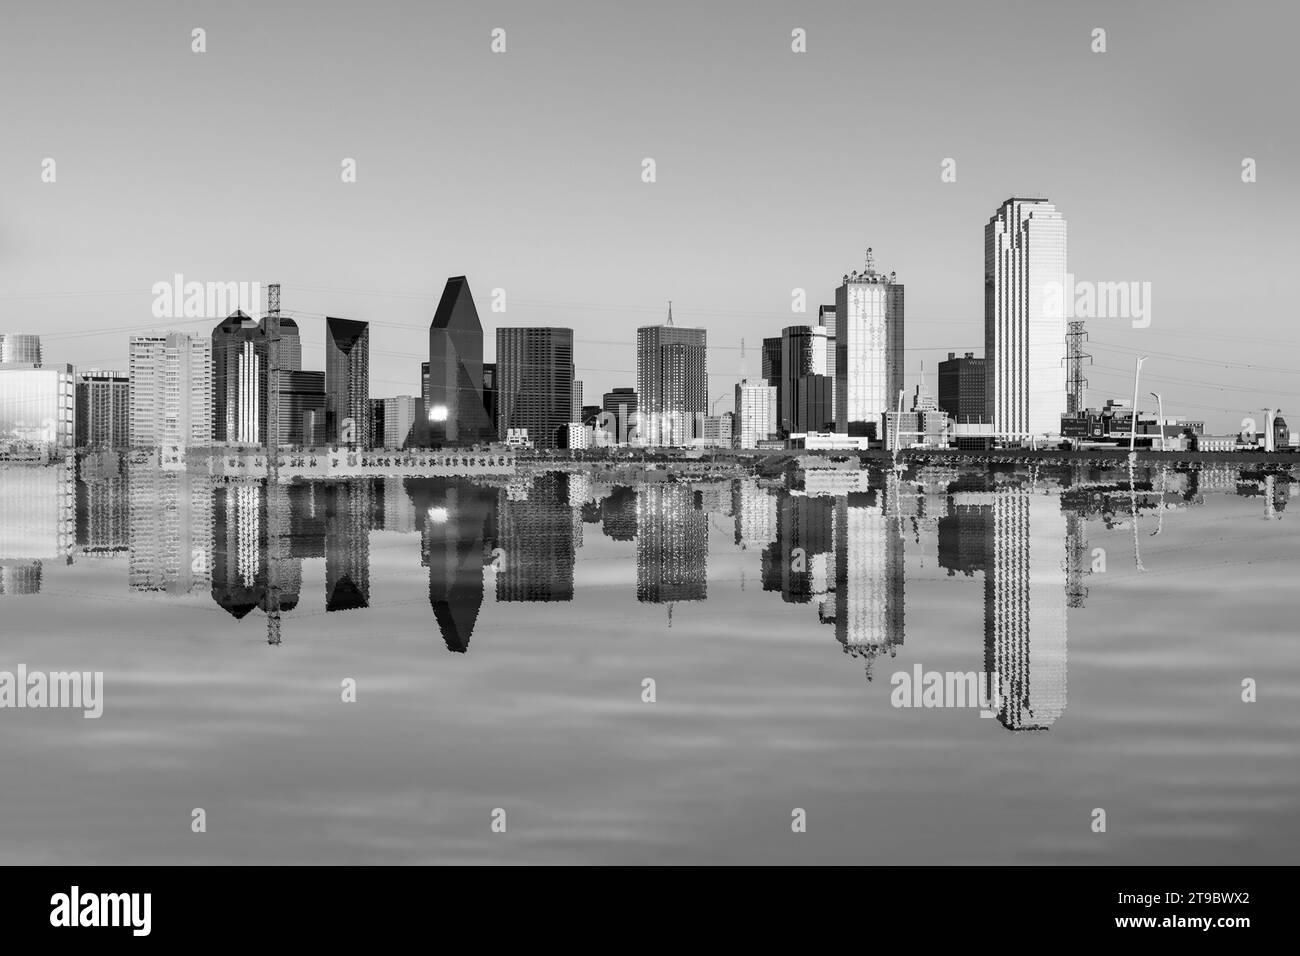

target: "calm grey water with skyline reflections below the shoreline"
[0,460,1300,864]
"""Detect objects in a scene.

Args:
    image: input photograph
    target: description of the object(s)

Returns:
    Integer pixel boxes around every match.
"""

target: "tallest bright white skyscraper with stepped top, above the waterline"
[984,199,1066,441]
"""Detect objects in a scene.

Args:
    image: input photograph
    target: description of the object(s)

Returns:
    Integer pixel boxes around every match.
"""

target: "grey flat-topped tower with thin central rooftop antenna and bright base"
[637,317,709,446]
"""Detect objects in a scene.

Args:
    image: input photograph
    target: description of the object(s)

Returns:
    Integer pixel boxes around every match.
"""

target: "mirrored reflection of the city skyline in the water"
[0,458,1295,731]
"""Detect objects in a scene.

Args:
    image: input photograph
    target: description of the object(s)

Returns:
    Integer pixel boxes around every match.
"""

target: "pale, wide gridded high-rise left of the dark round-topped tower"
[130,332,212,447]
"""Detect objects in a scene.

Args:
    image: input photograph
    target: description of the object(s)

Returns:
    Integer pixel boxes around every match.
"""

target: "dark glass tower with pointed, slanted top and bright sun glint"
[420,276,497,445]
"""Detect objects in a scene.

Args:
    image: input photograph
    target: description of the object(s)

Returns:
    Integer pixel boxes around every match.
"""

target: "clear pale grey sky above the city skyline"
[0,0,1300,432]
